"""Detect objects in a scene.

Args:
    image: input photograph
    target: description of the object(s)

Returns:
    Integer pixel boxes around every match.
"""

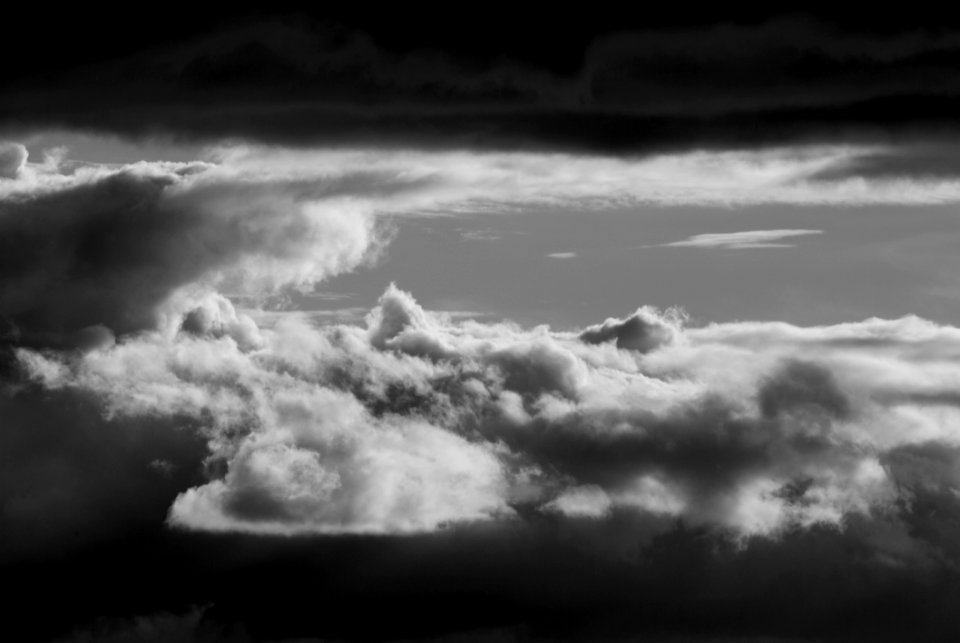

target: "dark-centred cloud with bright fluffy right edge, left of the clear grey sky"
[0,154,394,346]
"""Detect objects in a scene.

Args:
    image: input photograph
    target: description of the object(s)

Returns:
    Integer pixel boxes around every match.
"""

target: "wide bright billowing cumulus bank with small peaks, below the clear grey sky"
[18,286,960,556]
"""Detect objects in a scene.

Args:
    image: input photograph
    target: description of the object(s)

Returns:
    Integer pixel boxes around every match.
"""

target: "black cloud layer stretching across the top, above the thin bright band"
[9,14,960,152]
